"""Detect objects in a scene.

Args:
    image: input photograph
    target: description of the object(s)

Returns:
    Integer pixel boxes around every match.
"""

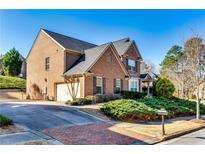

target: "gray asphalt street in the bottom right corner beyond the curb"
[160,129,205,145]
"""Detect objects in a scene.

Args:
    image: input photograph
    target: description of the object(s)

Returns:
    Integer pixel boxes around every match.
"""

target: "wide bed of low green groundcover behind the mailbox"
[101,97,205,121]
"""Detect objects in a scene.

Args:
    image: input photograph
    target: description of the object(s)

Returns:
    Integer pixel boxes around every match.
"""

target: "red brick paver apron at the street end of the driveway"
[43,123,151,145]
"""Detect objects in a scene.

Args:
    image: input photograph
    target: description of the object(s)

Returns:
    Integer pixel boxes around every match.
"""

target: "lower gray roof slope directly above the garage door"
[64,43,110,75]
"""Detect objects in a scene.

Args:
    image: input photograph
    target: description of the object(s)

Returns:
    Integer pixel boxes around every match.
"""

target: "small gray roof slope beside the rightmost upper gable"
[113,38,132,56]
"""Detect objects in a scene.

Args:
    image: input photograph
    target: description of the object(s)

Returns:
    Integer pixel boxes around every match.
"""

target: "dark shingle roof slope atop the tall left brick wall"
[42,29,96,53]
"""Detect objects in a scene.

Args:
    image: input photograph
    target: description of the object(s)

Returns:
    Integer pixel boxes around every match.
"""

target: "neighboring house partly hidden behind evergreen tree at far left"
[0,55,26,79]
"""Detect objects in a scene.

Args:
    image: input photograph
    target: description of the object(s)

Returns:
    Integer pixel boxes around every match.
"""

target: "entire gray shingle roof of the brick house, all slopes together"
[42,29,142,75]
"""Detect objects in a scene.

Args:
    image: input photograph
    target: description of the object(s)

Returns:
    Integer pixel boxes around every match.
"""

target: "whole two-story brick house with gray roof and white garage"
[26,29,150,101]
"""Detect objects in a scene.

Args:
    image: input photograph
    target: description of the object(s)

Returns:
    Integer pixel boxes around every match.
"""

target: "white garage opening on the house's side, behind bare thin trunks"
[56,83,80,102]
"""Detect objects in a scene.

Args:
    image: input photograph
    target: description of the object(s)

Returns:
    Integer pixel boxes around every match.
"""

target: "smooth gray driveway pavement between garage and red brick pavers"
[0,103,101,130]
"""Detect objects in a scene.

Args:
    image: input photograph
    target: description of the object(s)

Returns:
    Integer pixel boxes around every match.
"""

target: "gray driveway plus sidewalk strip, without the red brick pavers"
[0,102,103,145]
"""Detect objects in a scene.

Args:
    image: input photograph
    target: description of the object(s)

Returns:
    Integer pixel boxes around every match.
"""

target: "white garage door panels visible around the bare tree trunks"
[57,83,80,102]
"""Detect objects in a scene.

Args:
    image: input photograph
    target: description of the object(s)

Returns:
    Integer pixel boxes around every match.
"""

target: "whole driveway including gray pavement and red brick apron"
[0,102,149,145]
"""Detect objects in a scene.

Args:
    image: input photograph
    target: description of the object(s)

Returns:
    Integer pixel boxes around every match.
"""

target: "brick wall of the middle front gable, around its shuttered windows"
[85,47,127,96]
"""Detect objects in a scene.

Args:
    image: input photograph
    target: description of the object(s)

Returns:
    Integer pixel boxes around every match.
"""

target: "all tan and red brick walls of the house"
[26,31,143,100]
